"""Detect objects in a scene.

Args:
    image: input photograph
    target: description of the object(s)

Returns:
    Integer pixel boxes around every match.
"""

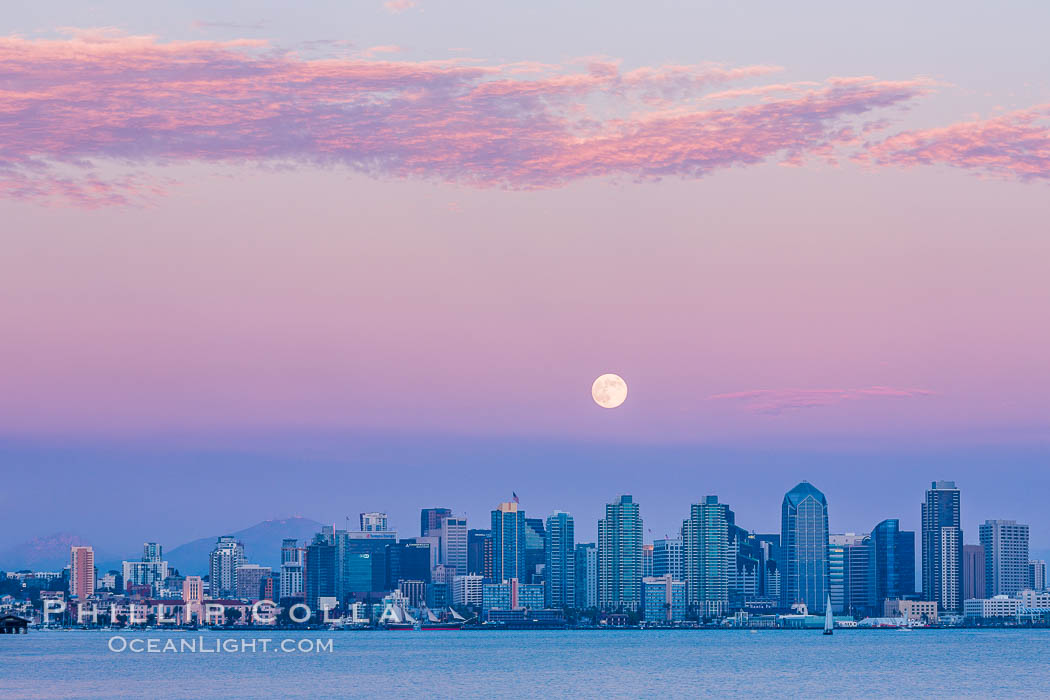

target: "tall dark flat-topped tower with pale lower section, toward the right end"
[922,481,963,613]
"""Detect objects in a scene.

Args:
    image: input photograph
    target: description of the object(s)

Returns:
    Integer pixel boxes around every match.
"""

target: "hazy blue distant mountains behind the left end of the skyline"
[0,517,321,575]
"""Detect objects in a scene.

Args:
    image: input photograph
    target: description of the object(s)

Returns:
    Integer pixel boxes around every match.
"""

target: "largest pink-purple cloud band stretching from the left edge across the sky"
[0,29,929,206]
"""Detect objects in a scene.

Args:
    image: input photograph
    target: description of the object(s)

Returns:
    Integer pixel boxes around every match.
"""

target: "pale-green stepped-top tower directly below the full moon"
[597,494,644,610]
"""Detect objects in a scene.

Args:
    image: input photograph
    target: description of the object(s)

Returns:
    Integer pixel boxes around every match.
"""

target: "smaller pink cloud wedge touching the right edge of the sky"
[861,105,1050,181]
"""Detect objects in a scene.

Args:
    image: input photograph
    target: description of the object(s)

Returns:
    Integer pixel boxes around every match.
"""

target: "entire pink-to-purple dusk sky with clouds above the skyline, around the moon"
[0,0,1050,548]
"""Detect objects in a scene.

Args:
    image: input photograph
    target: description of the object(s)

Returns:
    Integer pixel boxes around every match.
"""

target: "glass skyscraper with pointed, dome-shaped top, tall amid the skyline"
[780,482,828,613]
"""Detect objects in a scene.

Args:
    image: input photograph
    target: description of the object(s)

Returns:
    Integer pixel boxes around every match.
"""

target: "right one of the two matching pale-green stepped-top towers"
[681,495,730,617]
